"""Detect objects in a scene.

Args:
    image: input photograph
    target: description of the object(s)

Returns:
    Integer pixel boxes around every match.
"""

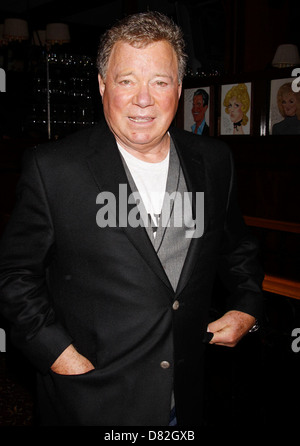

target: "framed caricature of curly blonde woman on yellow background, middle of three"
[219,82,252,135]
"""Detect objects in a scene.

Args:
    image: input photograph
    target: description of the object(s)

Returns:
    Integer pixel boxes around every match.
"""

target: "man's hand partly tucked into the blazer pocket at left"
[51,345,95,375]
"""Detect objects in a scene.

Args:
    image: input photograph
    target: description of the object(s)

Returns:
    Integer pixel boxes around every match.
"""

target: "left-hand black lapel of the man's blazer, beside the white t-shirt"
[87,122,172,288]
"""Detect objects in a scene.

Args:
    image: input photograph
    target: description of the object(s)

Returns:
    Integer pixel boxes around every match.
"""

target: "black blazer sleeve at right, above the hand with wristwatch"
[218,153,264,321]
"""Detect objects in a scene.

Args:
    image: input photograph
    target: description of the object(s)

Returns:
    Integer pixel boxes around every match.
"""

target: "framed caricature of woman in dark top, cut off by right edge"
[269,78,300,135]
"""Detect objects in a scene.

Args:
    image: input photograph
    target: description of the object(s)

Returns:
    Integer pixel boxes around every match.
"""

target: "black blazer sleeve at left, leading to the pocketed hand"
[0,149,72,373]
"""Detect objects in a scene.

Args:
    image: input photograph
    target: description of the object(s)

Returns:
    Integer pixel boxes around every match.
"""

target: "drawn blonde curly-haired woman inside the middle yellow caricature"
[223,84,250,135]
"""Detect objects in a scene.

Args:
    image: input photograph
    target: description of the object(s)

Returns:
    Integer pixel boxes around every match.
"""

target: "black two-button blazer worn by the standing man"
[0,119,263,426]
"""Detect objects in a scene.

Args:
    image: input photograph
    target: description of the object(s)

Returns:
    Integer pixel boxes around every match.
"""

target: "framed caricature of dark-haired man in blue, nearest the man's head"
[183,87,212,136]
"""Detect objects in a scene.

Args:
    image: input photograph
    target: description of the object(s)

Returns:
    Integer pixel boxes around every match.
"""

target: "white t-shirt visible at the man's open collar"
[118,144,170,230]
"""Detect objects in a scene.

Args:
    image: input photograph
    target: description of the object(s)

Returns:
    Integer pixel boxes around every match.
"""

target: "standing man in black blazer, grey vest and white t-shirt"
[0,13,262,426]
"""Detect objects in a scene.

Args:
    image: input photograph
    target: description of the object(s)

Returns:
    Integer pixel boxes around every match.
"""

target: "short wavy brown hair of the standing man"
[97,12,187,81]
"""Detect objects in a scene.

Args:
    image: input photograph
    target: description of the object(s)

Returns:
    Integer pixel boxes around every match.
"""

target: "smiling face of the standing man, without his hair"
[99,41,181,152]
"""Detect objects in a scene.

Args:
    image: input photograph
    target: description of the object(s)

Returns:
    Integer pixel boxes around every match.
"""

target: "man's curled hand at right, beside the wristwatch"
[207,311,255,347]
